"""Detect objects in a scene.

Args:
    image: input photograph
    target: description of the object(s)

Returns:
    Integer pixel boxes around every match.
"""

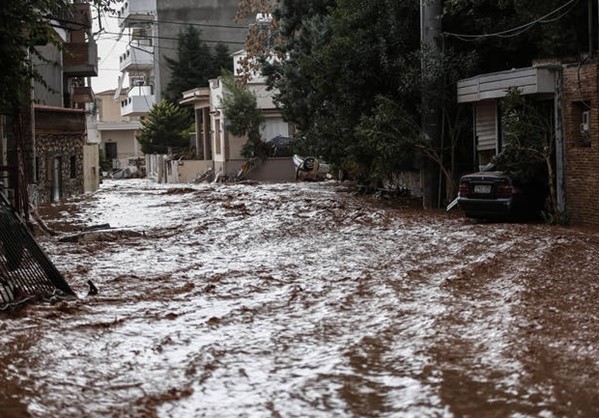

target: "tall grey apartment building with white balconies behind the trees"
[115,0,247,118]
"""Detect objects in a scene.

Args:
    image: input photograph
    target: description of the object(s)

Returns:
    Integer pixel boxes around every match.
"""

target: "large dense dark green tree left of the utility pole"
[265,0,420,177]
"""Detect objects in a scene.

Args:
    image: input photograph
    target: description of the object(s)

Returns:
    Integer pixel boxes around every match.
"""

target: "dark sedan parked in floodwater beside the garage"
[458,171,547,219]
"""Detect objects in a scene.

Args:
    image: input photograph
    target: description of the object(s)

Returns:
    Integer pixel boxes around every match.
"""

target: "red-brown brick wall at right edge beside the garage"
[563,64,599,225]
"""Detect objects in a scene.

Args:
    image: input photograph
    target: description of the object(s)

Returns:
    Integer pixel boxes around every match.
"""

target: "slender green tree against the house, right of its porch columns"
[222,74,273,159]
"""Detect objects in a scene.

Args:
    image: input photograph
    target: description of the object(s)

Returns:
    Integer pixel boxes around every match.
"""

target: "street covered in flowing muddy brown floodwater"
[0,180,599,418]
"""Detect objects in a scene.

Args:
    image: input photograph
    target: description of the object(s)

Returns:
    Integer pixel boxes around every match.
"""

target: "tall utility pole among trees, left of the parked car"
[420,0,443,209]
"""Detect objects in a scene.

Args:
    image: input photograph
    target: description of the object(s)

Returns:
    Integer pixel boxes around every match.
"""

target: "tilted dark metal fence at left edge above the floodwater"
[0,192,74,308]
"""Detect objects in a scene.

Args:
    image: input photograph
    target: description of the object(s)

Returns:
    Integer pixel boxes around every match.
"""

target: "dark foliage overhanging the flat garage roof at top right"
[443,0,588,73]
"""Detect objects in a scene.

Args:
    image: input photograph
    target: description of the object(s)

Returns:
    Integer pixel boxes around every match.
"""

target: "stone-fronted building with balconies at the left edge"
[0,0,99,207]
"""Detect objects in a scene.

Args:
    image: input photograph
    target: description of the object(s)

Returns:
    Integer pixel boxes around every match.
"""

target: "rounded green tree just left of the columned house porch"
[137,99,189,154]
